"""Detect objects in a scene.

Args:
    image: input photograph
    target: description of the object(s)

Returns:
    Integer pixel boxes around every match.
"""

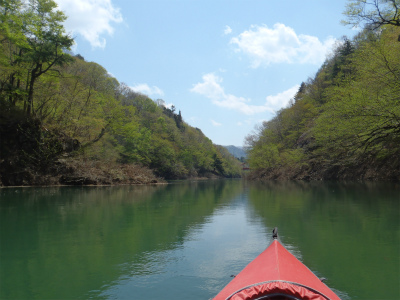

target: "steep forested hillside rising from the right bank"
[246,18,400,180]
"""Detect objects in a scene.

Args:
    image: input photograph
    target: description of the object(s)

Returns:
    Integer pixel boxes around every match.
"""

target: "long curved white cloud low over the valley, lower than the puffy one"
[190,73,299,115]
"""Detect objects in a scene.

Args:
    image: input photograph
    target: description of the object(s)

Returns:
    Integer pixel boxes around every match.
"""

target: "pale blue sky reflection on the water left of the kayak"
[96,184,268,299]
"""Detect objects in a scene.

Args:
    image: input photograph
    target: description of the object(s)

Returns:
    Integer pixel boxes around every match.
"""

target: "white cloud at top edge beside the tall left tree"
[55,0,123,48]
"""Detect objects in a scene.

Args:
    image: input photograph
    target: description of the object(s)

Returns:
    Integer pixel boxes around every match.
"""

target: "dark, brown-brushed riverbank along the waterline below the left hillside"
[0,115,239,186]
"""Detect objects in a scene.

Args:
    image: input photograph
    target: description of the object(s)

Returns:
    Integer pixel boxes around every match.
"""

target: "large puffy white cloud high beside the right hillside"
[230,23,335,68]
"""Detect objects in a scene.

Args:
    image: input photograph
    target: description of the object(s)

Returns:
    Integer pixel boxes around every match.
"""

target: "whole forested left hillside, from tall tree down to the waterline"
[0,0,240,185]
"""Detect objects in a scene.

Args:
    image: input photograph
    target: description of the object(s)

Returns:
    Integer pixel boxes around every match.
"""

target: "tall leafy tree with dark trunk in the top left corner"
[0,0,74,115]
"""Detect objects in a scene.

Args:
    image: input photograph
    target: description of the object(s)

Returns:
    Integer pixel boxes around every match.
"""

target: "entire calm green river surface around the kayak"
[0,180,400,300]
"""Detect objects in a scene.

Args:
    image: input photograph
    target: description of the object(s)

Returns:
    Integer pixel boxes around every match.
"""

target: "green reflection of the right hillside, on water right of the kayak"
[249,182,400,299]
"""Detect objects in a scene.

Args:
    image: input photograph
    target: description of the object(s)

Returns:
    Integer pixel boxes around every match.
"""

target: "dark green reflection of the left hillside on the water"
[0,181,245,299]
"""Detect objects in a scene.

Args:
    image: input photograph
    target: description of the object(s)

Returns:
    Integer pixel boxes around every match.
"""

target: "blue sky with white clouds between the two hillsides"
[56,0,355,146]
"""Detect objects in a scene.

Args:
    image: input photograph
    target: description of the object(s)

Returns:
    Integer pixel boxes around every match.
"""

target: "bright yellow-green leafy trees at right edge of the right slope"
[314,28,400,161]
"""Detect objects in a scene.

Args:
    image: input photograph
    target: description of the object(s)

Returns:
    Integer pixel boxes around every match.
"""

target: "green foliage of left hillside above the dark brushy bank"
[0,0,240,179]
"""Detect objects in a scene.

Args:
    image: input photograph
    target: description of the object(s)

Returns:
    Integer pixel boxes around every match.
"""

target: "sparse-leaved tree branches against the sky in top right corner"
[343,0,400,29]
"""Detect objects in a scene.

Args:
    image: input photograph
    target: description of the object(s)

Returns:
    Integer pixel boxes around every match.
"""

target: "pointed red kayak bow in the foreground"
[213,229,340,300]
